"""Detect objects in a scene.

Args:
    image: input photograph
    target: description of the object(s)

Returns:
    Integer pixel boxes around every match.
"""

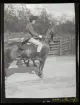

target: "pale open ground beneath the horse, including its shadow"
[5,56,76,98]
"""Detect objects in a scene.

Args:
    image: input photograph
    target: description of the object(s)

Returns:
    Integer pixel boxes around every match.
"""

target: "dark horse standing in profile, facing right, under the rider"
[4,29,54,78]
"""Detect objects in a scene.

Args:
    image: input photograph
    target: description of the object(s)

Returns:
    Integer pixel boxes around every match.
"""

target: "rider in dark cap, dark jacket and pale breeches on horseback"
[22,16,42,52]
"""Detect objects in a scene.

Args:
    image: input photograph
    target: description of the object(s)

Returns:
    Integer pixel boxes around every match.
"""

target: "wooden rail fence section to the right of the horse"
[49,36,76,55]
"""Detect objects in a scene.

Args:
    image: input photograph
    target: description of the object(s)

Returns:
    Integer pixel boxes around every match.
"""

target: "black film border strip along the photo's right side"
[75,3,79,102]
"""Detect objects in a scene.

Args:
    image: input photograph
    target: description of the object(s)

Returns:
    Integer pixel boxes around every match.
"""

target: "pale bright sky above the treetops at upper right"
[26,3,75,16]
